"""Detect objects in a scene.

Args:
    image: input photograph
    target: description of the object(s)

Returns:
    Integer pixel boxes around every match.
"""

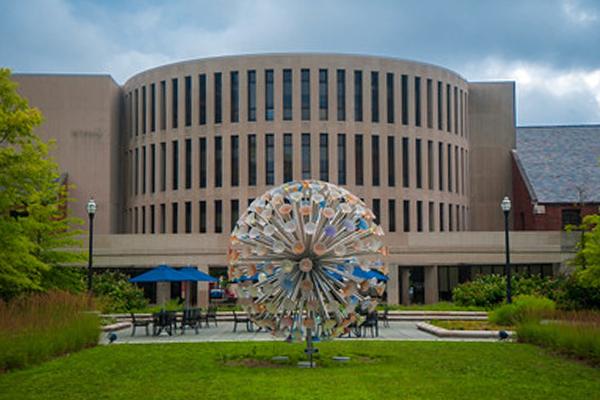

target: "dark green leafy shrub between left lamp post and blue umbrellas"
[93,272,148,313]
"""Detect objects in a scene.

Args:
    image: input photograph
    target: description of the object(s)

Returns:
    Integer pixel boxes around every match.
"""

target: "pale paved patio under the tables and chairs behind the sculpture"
[100,321,495,344]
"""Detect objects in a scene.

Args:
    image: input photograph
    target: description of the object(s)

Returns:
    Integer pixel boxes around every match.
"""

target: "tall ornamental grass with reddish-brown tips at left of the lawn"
[0,291,100,372]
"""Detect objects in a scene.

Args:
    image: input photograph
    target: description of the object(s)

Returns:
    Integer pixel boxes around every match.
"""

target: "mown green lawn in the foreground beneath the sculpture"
[0,340,600,400]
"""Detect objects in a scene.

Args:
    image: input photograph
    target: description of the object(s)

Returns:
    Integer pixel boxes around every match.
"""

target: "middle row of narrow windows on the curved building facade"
[127,133,468,195]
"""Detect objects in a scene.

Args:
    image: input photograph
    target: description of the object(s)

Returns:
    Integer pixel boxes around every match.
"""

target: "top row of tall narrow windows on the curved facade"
[126,68,467,136]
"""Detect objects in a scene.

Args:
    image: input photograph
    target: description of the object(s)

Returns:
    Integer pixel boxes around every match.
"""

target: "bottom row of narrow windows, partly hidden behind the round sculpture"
[126,199,468,233]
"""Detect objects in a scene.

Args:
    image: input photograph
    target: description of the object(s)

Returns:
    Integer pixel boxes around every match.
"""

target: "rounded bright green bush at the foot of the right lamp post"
[489,295,556,325]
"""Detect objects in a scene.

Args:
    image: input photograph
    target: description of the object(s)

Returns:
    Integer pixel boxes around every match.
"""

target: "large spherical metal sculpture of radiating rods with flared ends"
[228,180,387,341]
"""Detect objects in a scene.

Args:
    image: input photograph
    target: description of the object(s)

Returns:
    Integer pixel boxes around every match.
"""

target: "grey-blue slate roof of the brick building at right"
[516,125,600,203]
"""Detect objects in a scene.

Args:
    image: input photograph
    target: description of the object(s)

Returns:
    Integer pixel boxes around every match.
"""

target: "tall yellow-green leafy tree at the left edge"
[0,69,85,299]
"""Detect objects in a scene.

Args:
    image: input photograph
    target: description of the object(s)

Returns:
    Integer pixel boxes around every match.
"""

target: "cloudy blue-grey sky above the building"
[0,0,600,125]
